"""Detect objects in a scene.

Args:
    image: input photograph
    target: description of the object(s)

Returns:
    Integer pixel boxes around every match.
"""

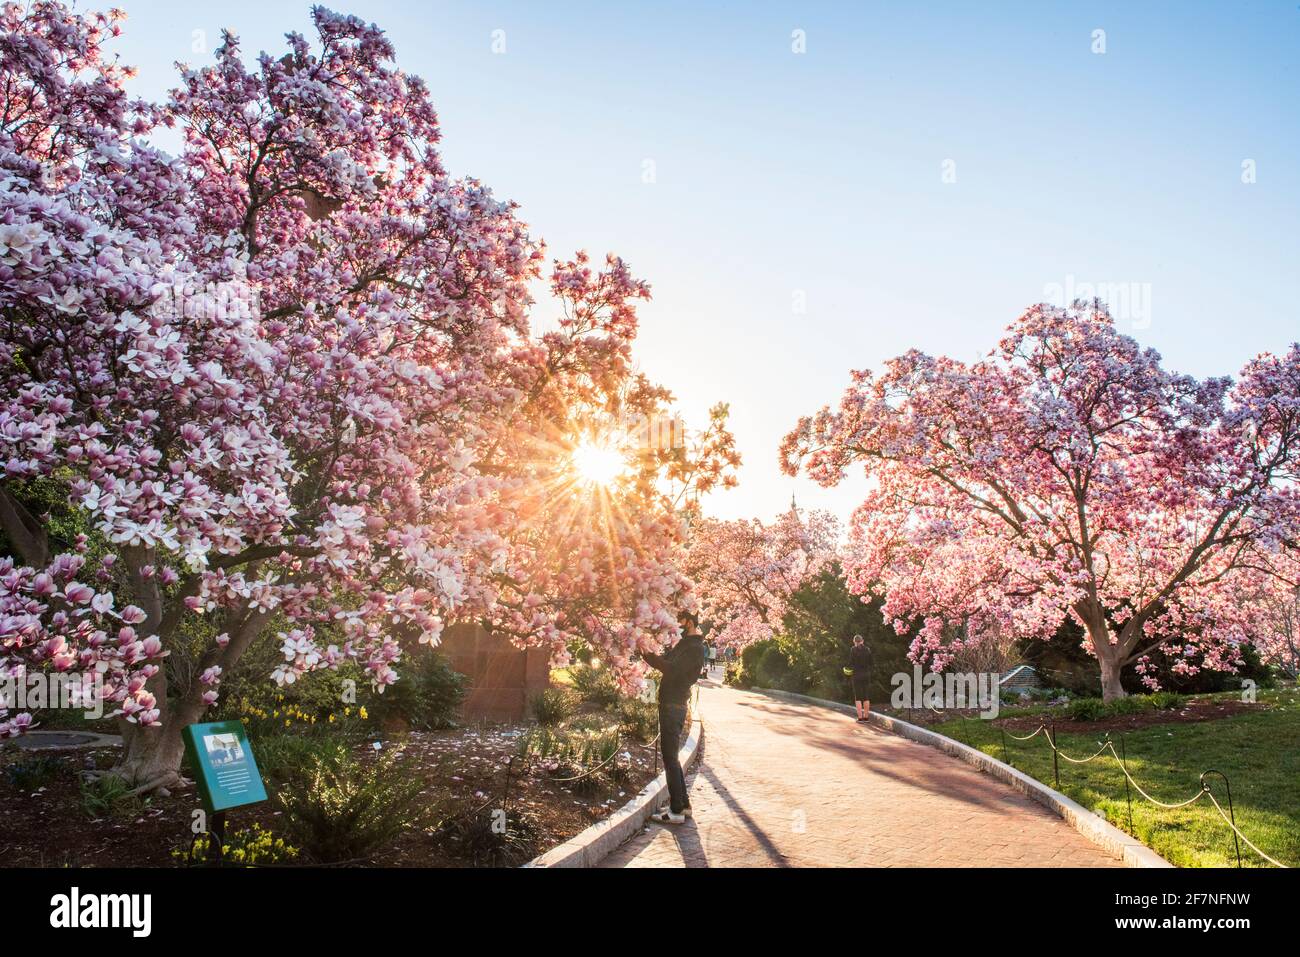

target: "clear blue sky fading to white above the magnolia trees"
[116,0,1300,518]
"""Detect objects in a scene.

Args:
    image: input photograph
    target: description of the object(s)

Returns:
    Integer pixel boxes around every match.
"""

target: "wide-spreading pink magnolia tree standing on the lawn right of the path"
[781,302,1300,700]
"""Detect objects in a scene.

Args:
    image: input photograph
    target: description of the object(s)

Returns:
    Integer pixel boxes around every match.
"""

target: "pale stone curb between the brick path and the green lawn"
[750,688,1174,867]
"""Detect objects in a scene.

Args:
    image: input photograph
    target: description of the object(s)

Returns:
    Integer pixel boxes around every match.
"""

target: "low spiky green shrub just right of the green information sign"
[273,750,429,863]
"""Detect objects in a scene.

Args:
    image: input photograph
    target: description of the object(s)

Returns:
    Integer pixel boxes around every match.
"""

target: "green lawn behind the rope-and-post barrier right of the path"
[930,688,1300,867]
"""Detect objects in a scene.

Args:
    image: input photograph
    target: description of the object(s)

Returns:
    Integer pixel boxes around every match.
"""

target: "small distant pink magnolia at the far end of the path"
[686,508,839,646]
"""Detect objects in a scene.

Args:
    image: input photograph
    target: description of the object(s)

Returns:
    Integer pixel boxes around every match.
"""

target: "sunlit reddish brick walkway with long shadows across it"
[602,683,1122,867]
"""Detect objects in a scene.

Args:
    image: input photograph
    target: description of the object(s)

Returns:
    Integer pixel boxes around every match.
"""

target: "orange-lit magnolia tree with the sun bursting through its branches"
[475,254,740,692]
